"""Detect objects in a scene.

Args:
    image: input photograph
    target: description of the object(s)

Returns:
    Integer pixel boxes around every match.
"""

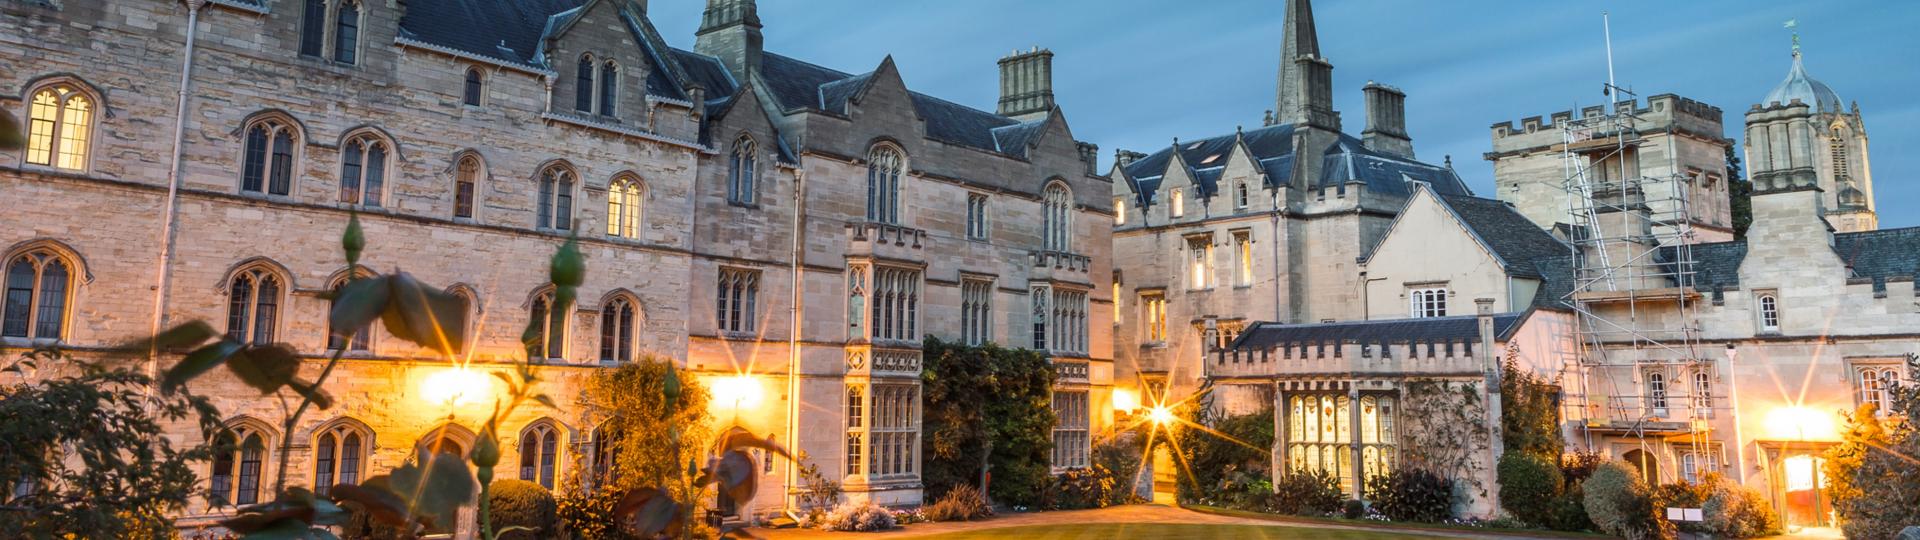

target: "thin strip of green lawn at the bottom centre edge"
[918,523,1432,540]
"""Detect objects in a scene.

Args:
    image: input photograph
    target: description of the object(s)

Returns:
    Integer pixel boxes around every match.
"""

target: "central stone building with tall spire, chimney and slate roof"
[1110,0,1469,405]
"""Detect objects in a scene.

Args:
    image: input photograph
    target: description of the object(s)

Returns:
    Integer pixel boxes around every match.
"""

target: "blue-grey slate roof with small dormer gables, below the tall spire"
[1125,123,1473,206]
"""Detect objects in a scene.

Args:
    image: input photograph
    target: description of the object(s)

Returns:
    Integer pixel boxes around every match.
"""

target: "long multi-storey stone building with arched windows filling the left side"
[0,0,1112,525]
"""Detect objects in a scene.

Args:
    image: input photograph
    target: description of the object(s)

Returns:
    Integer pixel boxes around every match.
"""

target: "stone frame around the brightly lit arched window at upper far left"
[19,77,108,175]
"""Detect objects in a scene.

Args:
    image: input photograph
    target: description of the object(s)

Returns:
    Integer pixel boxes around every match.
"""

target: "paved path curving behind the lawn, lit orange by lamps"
[753,503,1574,540]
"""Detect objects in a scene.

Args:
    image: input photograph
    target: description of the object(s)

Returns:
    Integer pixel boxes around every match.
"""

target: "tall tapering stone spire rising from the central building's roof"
[1269,0,1338,129]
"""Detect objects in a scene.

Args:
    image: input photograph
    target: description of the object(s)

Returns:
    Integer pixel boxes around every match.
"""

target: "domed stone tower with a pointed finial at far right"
[1745,44,1880,233]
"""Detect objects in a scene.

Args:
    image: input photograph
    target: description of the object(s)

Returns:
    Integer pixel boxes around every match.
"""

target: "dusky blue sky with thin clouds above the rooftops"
[649,0,1920,227]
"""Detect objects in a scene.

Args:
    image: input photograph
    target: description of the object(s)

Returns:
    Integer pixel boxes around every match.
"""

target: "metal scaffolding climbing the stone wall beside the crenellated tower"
[1561,14,1728,478]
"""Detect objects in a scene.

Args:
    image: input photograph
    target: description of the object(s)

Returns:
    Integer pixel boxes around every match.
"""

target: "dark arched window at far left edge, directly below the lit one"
[0,250,73,340]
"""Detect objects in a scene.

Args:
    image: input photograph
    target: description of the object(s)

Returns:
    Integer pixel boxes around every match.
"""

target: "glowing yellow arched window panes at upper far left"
[27,83,94,171]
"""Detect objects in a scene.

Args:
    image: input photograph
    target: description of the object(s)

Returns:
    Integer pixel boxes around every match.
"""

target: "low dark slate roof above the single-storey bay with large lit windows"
[1227,311,1530,352]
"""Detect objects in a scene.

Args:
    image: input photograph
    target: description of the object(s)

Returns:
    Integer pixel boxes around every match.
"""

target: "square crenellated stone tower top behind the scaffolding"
[1486,94,1734,242]
